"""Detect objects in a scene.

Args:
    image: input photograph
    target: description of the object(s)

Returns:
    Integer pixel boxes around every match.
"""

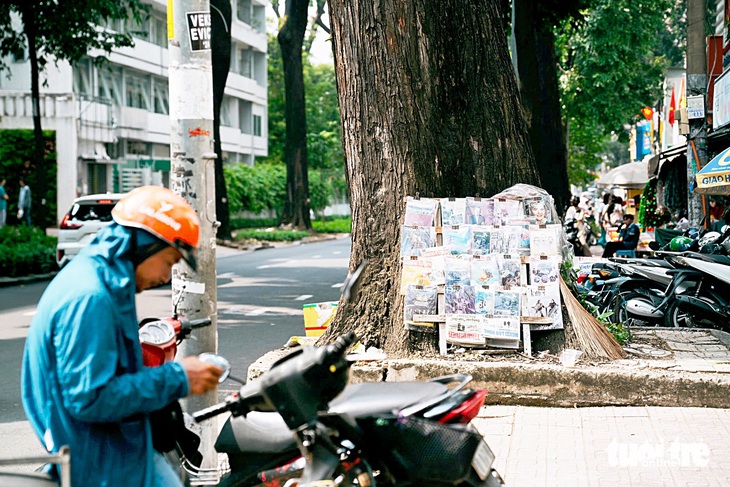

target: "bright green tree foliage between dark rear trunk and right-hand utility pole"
[556,0,683,184]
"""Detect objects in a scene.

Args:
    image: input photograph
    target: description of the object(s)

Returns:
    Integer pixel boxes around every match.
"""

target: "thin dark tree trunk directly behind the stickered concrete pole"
[210,0,232,239]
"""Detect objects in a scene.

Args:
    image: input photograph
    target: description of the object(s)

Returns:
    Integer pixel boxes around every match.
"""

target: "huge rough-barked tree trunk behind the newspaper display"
[324,0,539,355]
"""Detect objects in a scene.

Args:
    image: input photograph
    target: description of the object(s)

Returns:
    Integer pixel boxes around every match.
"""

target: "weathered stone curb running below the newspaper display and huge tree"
[248,349,730,408]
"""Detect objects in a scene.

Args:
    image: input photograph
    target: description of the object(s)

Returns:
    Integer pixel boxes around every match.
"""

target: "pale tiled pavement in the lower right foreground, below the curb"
[475,406,730,487]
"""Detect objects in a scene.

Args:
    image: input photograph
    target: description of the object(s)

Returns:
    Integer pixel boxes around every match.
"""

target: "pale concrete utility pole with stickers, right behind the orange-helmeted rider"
[167,0,218,472]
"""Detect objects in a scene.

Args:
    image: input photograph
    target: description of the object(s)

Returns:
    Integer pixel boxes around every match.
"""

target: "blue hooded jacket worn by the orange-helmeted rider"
[22,223,188,487]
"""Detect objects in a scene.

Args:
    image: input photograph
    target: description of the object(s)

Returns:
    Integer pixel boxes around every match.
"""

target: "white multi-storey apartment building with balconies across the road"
[0,0,268,225]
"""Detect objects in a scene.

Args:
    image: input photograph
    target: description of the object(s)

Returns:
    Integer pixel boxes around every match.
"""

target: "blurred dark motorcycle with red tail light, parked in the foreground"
[184,334,503,487]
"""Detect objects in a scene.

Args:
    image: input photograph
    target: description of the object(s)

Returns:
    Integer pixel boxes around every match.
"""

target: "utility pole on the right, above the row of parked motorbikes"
[685,0,707,228]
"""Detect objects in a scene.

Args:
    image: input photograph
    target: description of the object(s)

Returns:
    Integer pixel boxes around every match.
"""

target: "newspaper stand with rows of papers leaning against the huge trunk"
[401,189,562,355]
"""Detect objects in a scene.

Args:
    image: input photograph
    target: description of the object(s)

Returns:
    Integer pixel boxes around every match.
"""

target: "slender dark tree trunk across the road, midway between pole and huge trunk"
[278,0,312,230]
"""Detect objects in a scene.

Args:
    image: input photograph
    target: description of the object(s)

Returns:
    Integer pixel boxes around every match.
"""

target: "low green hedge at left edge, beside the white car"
[0,225,58,277]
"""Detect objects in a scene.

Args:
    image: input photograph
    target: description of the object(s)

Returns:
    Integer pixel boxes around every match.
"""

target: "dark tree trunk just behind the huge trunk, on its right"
[515,1,570,212]
